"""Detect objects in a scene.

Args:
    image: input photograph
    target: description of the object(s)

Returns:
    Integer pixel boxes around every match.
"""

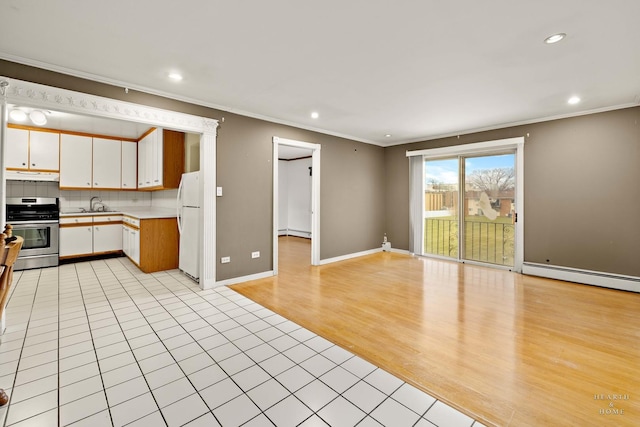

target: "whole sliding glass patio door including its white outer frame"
[407,138,524,272]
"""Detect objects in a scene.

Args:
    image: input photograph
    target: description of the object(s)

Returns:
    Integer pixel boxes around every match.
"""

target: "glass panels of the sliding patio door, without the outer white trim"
[423,151,516,267]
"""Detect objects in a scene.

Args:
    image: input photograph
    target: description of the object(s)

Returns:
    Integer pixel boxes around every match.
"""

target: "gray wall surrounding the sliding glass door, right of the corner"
[385,107,640,276]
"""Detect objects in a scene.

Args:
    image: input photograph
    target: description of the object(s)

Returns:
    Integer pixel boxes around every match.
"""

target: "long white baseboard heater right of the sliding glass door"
[522,262,640,292]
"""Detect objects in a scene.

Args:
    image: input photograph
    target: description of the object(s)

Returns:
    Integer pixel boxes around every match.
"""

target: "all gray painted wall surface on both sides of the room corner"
[6,60,640,280]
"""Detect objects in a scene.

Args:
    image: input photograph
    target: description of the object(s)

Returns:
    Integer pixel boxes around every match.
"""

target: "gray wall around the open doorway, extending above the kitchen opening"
[0,60,385,280]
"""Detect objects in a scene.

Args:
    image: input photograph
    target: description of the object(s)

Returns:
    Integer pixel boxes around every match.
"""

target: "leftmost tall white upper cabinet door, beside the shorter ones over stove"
[60,133,93,189]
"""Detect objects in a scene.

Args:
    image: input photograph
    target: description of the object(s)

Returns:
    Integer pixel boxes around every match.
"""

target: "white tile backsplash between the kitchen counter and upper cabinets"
[7,181,177,212]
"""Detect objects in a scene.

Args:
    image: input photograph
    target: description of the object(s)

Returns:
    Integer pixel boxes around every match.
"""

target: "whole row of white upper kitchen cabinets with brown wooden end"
[5,127,185,191]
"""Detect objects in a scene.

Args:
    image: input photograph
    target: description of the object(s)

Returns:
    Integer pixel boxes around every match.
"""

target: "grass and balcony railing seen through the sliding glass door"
[424,216,515,266]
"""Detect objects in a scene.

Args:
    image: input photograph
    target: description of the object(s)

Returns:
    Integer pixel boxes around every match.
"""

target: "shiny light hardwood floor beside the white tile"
[232,237,640,426]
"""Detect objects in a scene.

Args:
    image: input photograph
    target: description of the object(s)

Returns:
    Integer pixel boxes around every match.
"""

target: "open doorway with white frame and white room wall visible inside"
[273,137,321,275]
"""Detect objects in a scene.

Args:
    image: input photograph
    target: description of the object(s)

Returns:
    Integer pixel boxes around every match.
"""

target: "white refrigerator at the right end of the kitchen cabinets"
[177,172,200,281]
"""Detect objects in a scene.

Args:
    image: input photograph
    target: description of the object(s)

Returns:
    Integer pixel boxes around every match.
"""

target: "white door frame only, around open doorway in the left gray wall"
[272,136,322,276]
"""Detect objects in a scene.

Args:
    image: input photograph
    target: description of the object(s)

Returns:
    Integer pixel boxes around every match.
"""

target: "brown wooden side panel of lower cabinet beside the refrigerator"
[140,218,180,273]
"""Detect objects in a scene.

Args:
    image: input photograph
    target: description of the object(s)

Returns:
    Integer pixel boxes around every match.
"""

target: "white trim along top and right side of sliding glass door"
[406,136,525,273]
